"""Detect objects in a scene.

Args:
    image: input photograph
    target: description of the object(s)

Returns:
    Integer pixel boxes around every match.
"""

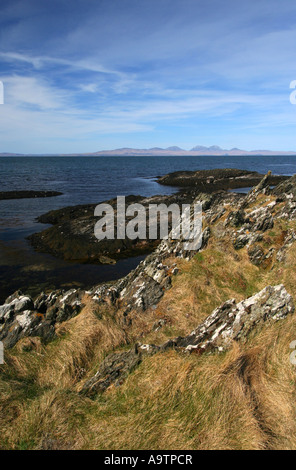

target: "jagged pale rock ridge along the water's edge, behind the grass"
[0,169,296,360]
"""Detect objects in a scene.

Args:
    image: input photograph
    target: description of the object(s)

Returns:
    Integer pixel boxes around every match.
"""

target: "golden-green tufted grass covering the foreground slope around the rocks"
[0,194,296,450]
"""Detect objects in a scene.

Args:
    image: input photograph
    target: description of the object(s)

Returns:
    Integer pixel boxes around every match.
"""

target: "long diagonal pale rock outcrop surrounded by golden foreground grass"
[80,285,294,397]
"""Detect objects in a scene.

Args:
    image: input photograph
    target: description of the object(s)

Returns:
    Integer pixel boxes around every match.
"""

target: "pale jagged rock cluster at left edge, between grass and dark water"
[0,289,84,349]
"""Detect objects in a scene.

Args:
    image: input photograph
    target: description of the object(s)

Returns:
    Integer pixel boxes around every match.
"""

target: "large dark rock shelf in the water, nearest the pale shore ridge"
[28,194,197,264]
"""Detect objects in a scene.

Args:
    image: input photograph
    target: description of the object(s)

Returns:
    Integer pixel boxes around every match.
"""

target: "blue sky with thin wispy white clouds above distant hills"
[0,0,296,154]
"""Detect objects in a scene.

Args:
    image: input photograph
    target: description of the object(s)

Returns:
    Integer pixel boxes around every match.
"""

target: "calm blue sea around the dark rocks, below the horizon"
[0,156,296,302]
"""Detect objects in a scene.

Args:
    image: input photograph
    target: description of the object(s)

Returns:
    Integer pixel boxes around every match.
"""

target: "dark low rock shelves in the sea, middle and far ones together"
[24,169,288,264]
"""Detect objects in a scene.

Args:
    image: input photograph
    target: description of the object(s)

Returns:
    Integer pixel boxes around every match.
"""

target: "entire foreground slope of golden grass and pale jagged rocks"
[0,168,296,449]
